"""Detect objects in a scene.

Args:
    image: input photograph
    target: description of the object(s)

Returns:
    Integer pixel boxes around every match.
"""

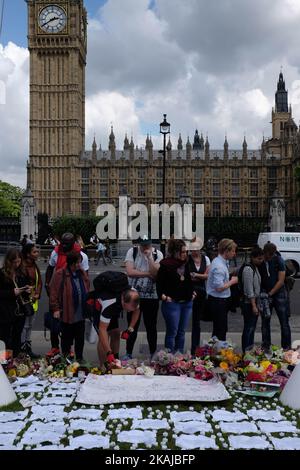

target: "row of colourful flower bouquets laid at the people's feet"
[3,338,300,388]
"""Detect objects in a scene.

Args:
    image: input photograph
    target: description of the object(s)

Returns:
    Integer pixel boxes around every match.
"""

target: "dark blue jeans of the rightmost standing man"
[261,289,292,349]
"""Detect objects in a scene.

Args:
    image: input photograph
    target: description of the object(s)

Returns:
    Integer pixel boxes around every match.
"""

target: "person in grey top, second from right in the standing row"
[238,247,264,352]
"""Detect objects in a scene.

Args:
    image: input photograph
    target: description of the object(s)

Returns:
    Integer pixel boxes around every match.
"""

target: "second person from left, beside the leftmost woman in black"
[21,243,42,359]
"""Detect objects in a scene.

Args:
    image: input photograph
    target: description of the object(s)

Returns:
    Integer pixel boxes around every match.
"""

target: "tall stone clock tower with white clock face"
[26,0,87,216]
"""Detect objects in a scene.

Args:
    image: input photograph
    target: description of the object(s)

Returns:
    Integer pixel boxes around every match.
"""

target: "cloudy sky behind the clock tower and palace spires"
[0,0,300,186]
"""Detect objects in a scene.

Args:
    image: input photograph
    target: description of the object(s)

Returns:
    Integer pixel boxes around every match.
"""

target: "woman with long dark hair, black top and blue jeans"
[156,239,194,353]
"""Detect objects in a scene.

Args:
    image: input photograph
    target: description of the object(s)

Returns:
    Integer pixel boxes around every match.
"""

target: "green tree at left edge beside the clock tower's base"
[0,180,24,217]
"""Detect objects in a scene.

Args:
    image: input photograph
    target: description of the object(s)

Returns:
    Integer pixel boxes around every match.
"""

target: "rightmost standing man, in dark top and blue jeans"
[260,243,292,351]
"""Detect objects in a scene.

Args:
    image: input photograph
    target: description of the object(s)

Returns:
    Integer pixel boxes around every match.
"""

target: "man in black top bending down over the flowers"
[87,271,140,368]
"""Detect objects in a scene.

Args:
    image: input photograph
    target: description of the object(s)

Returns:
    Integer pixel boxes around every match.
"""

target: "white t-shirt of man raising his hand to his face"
[125,247,163,299]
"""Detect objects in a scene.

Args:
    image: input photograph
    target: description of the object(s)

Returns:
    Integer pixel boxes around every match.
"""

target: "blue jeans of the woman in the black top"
[161,300,193,353]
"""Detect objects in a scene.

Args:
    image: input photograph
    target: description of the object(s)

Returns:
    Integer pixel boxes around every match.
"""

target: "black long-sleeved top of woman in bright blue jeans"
[156,258,194,302]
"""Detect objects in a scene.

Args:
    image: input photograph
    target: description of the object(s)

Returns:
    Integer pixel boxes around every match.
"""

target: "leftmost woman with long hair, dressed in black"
[0,248,31,357]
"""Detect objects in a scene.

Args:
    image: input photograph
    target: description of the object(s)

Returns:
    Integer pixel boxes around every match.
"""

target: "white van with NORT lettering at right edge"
[257,232,300,273]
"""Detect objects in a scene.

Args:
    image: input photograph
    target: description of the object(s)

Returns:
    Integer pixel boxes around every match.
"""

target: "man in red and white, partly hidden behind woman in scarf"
[45,233,89,357]
